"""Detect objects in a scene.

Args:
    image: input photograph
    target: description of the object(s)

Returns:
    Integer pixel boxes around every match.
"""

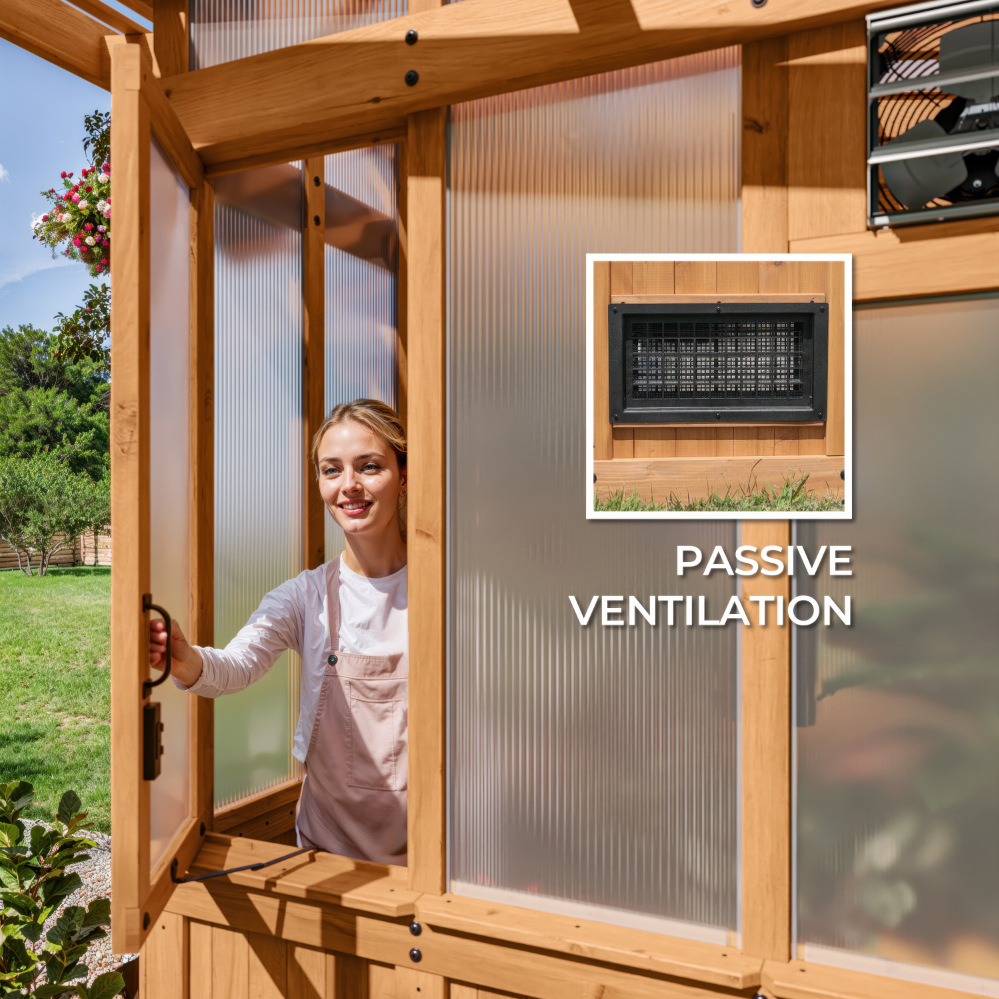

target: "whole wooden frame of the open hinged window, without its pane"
[110,44,214,953]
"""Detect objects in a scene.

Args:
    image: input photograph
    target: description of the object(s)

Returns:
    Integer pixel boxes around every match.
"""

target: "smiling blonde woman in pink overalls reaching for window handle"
[149,399,409,864]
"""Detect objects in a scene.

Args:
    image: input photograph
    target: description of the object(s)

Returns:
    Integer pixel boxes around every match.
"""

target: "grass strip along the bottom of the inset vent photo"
[593,475,843,513]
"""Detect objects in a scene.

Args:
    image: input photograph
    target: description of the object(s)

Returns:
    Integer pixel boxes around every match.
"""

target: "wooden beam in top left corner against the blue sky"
[0,0,111,90]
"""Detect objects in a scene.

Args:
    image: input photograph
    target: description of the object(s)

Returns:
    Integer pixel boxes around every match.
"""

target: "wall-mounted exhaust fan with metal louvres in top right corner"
[867,0,999,226]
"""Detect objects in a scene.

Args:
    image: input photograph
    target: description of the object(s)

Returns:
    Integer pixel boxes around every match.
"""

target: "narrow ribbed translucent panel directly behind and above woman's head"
[325,145,399,560]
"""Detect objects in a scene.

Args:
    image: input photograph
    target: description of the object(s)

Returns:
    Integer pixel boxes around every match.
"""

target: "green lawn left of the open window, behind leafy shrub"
[0,566,111,832]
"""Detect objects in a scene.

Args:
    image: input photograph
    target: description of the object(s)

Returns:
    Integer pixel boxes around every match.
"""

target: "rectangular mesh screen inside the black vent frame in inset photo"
[629,319,805,399]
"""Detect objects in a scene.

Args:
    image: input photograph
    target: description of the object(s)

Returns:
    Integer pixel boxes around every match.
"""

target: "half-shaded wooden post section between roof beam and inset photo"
[742,38,788,253]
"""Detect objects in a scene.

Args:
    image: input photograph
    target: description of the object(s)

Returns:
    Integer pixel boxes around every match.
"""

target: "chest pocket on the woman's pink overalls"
[347,677,408,791]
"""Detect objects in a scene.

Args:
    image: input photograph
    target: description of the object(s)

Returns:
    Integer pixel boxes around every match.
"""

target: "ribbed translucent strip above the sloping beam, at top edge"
[190,0,407,69]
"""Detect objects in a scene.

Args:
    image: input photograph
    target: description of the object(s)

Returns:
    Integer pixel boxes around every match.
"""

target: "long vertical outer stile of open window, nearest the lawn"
[111,37,150,954]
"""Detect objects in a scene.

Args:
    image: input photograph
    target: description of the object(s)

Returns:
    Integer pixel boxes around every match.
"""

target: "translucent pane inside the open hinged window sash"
[149,139,191,866]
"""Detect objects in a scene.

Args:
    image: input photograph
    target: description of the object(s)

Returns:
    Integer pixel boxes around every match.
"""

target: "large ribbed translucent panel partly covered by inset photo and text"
[448,49,739,928]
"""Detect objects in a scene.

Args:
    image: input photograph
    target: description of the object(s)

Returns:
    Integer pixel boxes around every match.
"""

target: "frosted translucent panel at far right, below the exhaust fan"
[796,298,999,996]
